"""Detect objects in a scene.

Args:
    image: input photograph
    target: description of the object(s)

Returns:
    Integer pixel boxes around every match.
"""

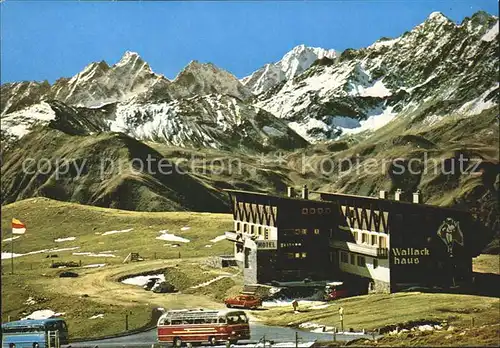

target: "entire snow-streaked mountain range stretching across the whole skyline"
[0,12,499,149]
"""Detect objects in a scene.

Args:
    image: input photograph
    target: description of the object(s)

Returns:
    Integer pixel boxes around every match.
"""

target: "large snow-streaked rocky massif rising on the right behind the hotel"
[256,12,498,142]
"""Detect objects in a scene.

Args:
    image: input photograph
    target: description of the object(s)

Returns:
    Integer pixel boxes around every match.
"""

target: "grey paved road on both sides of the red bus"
[66,323,371,348]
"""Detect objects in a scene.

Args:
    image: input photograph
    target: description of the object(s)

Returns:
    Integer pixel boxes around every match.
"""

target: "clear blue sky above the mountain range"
[0,0,498,83]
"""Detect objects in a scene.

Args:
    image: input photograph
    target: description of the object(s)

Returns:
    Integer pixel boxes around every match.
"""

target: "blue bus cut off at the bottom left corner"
[2,318,68,348]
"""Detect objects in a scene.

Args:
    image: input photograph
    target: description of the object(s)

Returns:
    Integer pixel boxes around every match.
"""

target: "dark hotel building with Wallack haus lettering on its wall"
[226,186,483,292]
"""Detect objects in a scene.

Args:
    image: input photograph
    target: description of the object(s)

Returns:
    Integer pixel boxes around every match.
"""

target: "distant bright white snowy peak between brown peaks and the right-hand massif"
[241,45,337,94]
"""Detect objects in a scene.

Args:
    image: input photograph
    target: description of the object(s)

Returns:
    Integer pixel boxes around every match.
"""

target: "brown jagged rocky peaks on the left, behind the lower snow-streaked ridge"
[0,52,252,115]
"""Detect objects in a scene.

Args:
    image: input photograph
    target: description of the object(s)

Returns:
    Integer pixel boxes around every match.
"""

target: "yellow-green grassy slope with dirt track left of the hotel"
[2,198,238,338]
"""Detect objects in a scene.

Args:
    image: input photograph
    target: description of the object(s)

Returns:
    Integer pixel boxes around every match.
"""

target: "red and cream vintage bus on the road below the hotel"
[157,309,250,347]
